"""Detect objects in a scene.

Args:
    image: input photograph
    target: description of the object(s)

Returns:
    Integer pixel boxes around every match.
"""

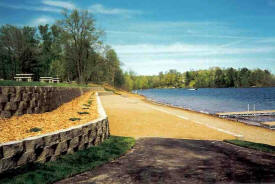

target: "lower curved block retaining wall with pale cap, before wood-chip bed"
[0,92,109,173]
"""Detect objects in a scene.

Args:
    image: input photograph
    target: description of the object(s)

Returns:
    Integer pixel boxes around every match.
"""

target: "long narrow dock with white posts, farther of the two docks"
[217,110,275,118]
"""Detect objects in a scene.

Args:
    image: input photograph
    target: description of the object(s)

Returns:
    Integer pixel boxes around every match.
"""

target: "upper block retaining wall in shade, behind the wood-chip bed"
[0,86,91,118]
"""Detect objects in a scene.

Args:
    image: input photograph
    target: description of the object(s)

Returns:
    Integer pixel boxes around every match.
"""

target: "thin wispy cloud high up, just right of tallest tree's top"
[89,4,142,15]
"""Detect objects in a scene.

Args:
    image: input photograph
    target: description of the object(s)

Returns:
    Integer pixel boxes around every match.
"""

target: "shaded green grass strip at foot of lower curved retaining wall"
[0,136,135,184]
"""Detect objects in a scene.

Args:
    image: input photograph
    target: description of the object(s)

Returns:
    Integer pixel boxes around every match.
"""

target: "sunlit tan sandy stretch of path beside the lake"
[101,95,275,145]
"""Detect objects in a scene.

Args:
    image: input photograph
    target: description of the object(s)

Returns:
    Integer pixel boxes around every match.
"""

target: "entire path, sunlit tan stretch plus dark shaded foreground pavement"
[56,95,275,184]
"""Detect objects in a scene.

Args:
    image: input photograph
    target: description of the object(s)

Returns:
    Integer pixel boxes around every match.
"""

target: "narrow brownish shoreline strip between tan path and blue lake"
[133,93,275,130]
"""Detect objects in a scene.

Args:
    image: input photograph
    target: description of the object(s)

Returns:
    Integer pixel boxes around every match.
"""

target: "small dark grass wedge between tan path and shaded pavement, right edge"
[224,140,275,153]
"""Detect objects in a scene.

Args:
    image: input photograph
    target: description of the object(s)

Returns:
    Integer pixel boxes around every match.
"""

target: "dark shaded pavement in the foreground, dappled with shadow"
[58,138,275,184]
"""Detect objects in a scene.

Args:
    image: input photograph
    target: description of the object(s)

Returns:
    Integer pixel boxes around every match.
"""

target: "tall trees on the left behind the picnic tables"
[0,10,124,87]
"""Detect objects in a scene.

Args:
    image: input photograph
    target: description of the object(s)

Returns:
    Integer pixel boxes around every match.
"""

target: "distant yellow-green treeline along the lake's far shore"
[124,67,275,90]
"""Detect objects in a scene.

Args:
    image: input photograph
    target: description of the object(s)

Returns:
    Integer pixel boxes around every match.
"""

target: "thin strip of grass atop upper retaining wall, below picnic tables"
[0,80,89,87]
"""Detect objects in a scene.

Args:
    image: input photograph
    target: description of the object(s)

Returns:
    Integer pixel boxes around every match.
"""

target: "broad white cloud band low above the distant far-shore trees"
[112,40,275,75]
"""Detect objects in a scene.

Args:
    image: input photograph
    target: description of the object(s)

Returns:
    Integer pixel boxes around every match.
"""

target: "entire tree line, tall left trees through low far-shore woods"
[0,10,275,91]
